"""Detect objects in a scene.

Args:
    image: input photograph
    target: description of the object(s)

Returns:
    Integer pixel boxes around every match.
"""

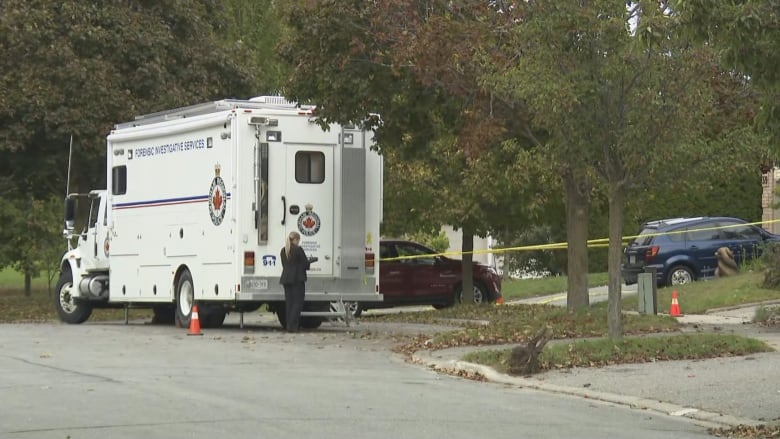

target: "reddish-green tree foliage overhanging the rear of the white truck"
[281,0,540,242]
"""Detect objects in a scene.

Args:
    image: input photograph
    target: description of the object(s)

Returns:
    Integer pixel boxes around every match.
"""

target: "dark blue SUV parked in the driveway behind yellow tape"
[620,217,780,286]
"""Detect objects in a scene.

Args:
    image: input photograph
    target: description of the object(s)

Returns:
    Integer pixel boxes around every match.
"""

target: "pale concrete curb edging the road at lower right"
[411,351,765,428]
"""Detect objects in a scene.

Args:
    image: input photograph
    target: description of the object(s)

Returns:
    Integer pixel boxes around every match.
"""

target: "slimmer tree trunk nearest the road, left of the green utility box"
[607,182,626,338]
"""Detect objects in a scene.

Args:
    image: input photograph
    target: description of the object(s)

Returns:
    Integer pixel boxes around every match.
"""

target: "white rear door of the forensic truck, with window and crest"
[284,144,337,276]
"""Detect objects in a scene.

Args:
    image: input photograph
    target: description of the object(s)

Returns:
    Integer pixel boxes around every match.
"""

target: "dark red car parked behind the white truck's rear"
[349,240,501,316]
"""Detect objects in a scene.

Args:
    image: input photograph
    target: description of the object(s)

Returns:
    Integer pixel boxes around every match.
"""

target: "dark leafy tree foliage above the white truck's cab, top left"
[0,0,253,198]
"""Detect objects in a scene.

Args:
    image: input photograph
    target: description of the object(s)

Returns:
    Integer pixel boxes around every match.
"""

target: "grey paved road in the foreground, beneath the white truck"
[0,321,708,439]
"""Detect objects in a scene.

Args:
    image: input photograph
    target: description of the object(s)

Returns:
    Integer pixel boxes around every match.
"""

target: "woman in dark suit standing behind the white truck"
[279,231,310,332]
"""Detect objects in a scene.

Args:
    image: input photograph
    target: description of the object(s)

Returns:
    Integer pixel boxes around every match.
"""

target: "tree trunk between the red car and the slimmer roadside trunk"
[563,172,590,309]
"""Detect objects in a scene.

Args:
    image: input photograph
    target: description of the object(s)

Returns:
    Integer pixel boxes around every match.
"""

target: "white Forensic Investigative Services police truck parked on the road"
[55,96,383,328]
